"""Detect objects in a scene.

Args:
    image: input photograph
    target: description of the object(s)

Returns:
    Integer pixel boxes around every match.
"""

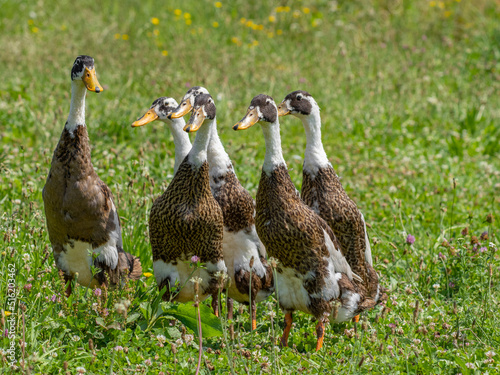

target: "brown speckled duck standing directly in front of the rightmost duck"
[233,94,362,351]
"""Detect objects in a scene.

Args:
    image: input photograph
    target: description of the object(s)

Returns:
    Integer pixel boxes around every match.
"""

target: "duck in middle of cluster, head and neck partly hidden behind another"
[170,86,274,336]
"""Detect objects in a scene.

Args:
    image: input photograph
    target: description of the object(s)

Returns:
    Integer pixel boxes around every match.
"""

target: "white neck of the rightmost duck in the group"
[300,108,330,174]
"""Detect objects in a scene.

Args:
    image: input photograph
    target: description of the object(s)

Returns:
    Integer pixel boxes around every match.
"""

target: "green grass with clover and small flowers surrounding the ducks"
[0,0,500,374]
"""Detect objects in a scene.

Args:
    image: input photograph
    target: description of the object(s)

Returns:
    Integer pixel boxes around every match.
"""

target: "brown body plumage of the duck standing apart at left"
[42,126,142,292]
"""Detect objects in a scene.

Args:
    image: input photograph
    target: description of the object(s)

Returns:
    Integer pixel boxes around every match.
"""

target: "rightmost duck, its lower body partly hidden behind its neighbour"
[278,90,387,310]
